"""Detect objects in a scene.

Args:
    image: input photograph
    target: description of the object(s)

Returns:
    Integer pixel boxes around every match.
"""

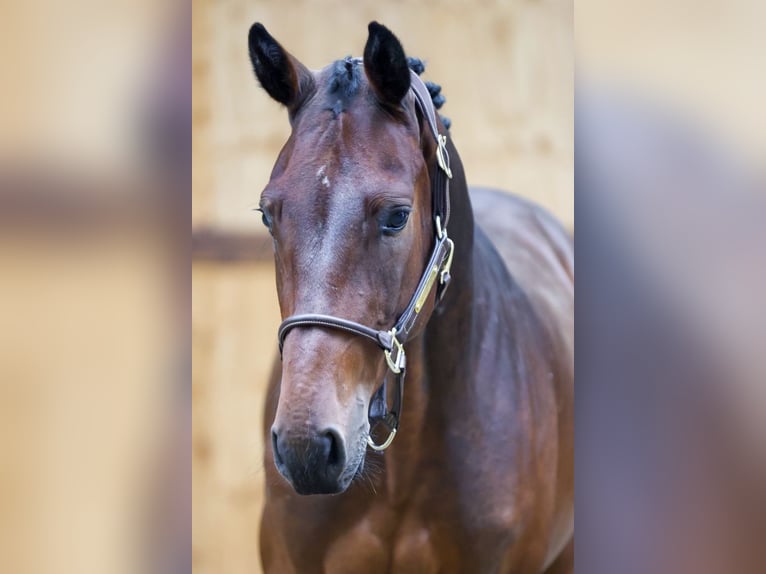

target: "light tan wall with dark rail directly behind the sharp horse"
[192,0,574,574]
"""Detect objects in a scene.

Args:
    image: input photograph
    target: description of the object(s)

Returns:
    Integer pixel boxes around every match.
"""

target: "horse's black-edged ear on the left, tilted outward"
[247,22,314,112]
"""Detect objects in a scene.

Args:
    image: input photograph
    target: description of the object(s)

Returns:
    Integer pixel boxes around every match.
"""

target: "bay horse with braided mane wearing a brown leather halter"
[248,22,574,574]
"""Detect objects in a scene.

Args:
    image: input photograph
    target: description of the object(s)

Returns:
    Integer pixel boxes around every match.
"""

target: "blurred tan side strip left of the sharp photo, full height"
[0,0,191,574]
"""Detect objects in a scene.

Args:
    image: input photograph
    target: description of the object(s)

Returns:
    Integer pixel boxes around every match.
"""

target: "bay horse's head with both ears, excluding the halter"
[249,22,448,494]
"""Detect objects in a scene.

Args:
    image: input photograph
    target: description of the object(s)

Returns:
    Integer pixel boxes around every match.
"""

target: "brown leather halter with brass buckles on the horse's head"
[278,71,455,451]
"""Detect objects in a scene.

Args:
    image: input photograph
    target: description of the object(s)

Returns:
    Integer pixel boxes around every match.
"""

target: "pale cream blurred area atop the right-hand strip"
[575,0,766,168]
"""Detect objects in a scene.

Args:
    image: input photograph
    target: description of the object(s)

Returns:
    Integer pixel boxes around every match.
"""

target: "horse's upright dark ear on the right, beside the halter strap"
[364,22,410,106]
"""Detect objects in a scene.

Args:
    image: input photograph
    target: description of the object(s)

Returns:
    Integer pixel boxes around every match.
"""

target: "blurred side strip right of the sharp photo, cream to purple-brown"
[575,0,766,574]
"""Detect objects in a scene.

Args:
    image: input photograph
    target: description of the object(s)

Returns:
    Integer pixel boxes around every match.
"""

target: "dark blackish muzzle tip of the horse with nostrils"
[271,426,348,494]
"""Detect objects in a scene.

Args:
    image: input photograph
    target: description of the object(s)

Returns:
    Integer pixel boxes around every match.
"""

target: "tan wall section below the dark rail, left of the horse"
[192,262,279,574]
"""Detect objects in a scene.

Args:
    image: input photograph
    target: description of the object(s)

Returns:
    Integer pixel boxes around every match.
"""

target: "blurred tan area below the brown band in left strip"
[0,217,176,574]
